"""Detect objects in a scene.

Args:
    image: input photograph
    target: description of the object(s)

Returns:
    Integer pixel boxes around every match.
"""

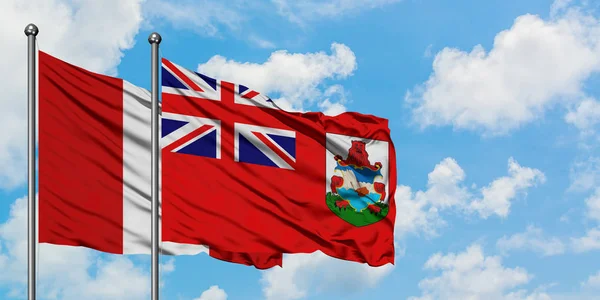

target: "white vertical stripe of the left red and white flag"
[123,80,208,255]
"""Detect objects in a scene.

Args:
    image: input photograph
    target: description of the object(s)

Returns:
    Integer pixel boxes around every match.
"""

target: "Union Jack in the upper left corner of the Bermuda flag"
[161,58,296,170]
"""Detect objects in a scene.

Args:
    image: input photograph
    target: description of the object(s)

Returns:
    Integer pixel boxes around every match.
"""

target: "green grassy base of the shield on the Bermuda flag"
[325,192,390,227]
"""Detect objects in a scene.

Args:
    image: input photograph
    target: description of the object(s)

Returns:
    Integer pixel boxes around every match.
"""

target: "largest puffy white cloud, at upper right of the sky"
[406,1,600,135]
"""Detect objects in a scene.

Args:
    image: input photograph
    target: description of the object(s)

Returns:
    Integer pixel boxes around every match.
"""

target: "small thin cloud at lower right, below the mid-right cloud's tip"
[496,226,566,256]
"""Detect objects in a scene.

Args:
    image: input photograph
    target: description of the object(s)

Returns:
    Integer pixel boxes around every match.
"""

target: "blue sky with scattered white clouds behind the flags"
[0,0,600,300]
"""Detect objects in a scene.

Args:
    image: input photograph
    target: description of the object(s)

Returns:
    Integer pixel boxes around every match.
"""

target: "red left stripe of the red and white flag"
[39,52,123,253]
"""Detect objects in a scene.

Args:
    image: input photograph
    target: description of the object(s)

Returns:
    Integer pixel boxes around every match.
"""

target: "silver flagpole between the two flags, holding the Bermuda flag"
[148,32,162,300]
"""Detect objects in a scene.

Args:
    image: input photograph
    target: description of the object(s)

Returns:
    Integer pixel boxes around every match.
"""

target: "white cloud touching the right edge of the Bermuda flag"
[396,157,545,236]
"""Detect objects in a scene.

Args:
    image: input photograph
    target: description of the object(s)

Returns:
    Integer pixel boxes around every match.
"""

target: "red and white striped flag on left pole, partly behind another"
[39,51,282,269]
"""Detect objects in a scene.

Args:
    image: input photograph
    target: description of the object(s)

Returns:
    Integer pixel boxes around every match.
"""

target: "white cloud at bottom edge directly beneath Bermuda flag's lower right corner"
[260,251,394,300]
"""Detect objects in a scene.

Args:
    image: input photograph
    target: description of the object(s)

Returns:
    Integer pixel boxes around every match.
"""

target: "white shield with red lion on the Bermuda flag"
[325,133,389,226]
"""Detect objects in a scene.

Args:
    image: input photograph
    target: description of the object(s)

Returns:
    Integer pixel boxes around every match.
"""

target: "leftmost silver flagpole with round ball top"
[25,24,39,300]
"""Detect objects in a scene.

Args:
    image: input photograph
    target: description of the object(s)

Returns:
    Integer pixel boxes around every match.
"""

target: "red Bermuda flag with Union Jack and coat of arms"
[161,59,396,266]
